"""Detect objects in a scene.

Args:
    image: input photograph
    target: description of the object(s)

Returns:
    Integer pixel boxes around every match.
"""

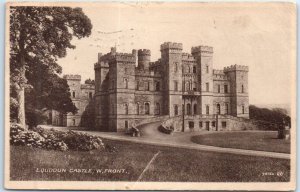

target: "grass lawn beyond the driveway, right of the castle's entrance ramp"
[191,131,290,153]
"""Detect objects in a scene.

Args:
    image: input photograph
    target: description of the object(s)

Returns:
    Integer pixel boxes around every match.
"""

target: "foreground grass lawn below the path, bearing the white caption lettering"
[10,140,290,182]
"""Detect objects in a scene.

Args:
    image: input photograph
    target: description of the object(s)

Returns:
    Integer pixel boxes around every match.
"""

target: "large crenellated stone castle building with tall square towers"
[93,42,249,131]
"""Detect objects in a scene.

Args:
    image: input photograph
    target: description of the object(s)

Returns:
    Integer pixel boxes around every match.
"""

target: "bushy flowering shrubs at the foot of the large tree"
[10,123,105,151]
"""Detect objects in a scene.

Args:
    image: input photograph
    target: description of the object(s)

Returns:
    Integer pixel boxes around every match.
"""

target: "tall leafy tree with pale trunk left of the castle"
[10,6,92,127]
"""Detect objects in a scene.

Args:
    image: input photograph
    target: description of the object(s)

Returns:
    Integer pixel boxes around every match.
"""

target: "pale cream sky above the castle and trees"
[59,3,296,105]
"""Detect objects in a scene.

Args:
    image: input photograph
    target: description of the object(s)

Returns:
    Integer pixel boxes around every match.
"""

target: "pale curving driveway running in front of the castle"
[42,122,290,159]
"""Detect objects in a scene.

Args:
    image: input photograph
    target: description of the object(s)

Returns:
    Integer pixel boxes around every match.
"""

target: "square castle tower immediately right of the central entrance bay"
[192,46,214,115]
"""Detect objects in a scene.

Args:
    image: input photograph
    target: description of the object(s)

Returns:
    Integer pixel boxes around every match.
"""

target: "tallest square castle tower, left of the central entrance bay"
[160,42,182,116]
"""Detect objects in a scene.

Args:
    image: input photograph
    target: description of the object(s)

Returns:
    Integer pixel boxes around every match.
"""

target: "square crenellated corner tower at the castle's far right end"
[224,65,249,118]
